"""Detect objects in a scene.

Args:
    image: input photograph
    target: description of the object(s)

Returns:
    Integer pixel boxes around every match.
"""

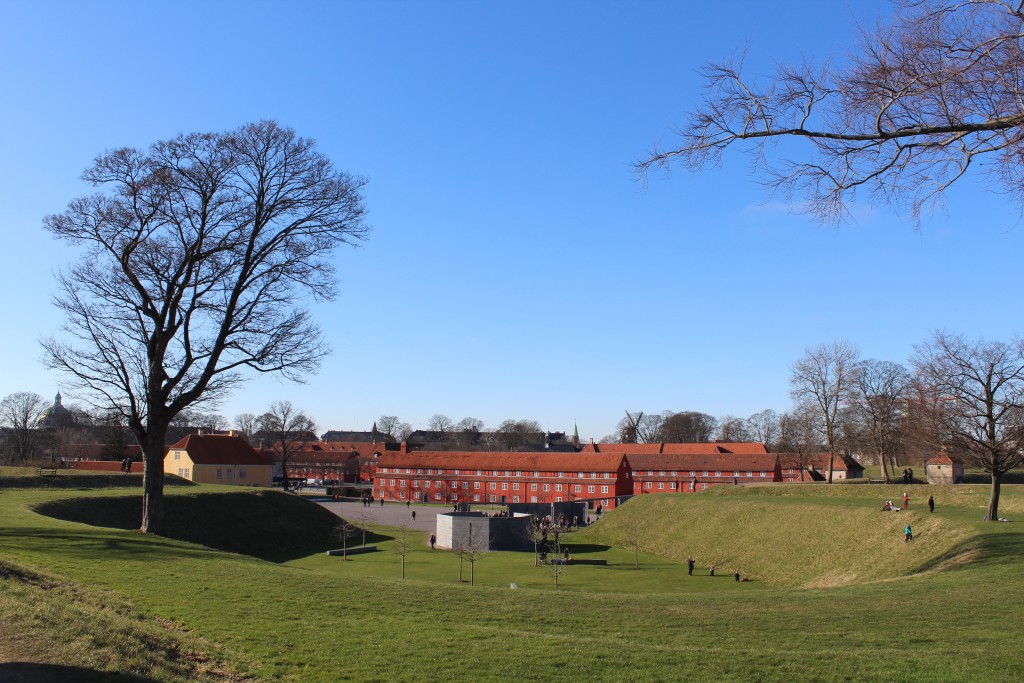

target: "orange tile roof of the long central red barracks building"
[377,451,623,472]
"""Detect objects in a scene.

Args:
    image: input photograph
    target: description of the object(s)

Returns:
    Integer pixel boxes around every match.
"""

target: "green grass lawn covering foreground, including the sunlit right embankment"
[0,477,1024,681]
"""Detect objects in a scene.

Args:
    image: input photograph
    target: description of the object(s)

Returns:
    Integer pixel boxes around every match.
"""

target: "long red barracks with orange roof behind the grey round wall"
[374,451,633,509]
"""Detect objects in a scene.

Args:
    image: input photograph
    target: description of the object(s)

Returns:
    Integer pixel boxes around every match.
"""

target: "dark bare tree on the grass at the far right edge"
[912,332,1024,520]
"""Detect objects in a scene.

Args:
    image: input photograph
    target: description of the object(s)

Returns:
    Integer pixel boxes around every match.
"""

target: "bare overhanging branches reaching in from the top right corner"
[637,0,1024,221]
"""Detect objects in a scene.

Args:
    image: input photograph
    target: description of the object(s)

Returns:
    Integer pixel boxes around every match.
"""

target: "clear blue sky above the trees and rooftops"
[0,0,1024,439]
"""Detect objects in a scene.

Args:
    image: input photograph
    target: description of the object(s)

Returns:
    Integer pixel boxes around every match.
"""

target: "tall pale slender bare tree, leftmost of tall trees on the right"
[790,339,859,483]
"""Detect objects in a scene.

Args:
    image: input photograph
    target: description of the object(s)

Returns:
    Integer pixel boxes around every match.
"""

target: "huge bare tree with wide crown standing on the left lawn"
[43,121,367,532]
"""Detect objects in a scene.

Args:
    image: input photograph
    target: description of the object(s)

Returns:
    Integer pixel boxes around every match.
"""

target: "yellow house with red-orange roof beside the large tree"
[164,432,273,486]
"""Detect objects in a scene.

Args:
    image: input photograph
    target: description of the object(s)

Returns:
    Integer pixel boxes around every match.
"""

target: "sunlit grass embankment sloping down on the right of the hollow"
[580,484,1007,588]
